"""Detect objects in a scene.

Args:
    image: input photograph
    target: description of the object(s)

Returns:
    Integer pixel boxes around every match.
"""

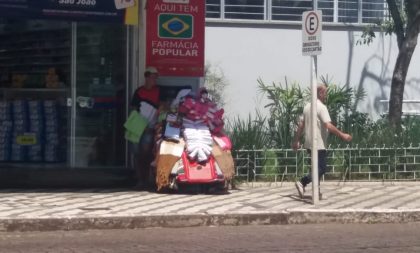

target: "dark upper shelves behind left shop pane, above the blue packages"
[0,21,71,88]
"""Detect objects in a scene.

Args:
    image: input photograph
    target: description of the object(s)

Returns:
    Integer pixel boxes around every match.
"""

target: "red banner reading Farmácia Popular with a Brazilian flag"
[146,0,205,77]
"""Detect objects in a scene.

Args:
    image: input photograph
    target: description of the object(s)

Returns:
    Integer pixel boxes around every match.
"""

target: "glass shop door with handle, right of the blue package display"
[69,22,128,168]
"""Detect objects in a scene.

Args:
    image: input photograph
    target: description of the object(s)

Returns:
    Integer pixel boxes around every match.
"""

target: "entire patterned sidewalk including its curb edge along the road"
[0,182,420,231]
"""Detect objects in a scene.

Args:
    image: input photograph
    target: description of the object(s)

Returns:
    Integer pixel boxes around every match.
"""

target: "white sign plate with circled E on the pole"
[302,11,322,55]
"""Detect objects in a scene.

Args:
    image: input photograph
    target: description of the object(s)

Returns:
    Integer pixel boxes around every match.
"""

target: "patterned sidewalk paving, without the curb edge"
[0,182,420,219]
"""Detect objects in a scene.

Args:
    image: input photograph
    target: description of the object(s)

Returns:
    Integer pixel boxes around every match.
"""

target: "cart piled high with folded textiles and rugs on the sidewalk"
[155,89,235,190]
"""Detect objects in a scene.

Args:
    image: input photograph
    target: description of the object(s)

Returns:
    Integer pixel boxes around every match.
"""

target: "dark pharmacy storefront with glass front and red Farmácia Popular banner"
[0,0,205,180]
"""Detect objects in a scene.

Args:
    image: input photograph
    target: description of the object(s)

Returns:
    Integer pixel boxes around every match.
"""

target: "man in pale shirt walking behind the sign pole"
[292,84,352,199]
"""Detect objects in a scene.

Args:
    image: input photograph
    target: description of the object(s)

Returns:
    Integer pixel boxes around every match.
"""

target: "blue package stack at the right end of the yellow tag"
[28,100,44,162]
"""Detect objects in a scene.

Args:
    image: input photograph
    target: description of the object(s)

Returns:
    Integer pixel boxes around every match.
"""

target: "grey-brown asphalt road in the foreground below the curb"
[0,223,420,253]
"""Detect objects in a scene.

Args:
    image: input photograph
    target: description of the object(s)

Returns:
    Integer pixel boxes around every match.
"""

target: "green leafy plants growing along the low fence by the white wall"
[227,74,420,181]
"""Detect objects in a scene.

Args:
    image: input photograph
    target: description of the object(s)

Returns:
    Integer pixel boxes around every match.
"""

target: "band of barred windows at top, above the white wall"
[206,0,386,23]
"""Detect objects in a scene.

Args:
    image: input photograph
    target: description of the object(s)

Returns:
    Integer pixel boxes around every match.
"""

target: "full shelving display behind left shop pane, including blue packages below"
[0,20,71,163]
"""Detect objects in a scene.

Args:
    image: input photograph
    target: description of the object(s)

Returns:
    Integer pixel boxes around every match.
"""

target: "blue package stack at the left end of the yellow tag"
[11,100,29,162]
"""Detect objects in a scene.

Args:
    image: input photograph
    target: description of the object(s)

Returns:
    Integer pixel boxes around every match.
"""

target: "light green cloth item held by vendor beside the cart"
[124,110,148,143]
